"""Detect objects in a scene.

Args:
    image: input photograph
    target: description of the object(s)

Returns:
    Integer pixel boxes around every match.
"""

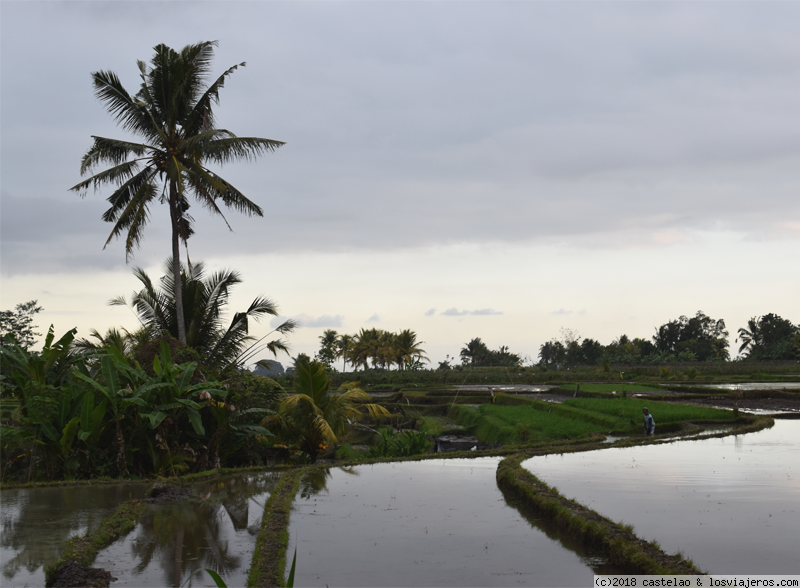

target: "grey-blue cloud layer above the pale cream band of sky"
[0,2,800,273]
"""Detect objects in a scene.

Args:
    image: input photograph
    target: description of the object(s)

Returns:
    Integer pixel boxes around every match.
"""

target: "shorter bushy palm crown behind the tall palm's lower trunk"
[109,259,295,368]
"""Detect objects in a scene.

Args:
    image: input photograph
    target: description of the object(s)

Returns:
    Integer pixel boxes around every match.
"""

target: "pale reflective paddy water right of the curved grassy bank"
[523,417,800,574]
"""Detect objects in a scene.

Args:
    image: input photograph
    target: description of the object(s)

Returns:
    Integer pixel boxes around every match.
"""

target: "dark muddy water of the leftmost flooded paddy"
[0,484,148,587]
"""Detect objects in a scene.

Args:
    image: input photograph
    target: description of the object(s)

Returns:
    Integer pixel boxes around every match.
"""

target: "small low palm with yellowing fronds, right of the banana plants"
[261,357,391,461]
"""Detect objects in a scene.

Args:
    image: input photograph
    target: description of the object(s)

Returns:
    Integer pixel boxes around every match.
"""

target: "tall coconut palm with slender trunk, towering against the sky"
[71,41,283,343]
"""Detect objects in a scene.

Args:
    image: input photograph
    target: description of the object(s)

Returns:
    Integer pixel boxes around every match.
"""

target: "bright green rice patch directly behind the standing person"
[564,398,734,427]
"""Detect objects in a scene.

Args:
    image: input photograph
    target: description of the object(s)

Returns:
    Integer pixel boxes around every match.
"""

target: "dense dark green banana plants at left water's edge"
[2,338,276,479]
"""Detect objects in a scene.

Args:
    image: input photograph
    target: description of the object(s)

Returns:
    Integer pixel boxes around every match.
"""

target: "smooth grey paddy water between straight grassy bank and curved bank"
[287,458,620,586]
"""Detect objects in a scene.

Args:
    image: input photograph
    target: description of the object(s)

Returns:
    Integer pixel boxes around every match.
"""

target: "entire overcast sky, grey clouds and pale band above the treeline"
[0,0,800,363]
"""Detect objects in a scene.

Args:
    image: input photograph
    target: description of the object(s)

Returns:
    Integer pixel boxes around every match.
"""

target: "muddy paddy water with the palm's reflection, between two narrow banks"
[94,473,278,587]
